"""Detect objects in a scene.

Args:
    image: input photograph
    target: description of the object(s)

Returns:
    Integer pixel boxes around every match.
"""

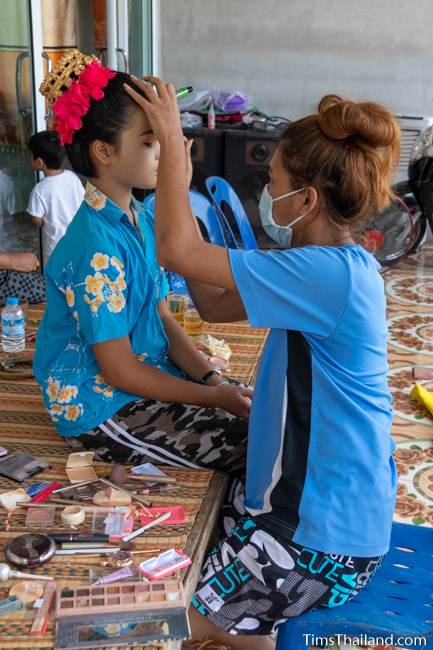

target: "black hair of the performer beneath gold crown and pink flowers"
[65,72,144,177]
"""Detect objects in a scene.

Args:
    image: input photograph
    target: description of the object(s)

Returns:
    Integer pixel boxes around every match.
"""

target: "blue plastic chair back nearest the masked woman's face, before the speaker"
[206,176,258,250]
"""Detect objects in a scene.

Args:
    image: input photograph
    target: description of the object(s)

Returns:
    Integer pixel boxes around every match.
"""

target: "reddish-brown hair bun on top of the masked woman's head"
[319,95,400,147]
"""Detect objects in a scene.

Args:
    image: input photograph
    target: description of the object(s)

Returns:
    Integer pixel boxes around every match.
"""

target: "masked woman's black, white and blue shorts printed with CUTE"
[192,480,384,636]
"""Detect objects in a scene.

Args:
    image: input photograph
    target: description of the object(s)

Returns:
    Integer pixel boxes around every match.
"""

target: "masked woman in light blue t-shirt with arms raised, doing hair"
[126,78,400,650]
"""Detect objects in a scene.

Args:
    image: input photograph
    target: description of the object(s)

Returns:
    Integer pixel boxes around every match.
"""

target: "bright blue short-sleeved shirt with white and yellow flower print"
[34,183,181,436]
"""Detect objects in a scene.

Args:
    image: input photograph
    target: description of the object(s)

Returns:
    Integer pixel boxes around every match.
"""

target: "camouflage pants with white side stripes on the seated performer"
[65,399,248,476]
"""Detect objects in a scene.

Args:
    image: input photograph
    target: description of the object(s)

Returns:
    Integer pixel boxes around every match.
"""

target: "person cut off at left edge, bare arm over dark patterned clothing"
[0,253,45,305]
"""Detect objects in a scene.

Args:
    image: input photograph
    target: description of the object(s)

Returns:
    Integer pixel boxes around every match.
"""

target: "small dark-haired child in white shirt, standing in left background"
[27,131,84,266]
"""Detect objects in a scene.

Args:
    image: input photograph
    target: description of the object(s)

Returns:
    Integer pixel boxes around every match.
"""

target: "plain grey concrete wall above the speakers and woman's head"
[161,0,433,119]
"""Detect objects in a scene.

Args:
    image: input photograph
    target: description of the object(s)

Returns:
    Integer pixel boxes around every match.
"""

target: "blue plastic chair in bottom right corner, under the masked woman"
[277,524,433,650]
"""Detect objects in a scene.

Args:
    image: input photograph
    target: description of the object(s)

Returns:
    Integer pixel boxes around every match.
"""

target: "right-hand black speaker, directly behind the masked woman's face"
[224,129,282,248]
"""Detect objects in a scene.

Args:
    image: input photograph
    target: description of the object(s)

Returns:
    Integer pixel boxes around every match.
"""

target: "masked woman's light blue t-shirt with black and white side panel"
[229,245,397,557]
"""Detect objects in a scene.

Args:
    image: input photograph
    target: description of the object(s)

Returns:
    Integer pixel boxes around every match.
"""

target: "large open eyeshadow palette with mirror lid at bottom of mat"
[55,580,191,650]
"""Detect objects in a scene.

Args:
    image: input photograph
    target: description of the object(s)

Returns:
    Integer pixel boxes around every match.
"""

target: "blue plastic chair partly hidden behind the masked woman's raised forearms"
[143,190,227,295]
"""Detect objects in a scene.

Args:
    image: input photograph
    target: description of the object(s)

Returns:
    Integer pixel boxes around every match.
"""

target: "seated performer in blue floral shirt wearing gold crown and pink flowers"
[34,50,251,474]
